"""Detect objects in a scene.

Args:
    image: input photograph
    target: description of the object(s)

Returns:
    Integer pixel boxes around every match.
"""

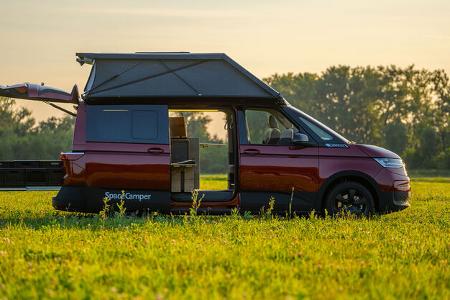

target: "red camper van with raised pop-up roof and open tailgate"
[0,53,410,215]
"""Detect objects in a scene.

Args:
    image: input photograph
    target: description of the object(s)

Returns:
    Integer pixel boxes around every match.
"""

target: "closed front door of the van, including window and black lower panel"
[239,108,319,213]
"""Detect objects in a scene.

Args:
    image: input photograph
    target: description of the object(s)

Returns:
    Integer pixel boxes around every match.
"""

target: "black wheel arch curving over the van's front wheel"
[319,170,380,211]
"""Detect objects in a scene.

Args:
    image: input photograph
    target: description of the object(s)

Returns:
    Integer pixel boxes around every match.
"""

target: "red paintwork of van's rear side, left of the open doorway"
[66,104,170,191]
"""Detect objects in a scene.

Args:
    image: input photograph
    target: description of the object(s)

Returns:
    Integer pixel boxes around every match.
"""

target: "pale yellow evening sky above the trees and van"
[0,0,450,120]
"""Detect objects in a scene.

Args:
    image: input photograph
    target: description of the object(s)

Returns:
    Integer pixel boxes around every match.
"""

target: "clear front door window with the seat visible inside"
[245,109,303,145]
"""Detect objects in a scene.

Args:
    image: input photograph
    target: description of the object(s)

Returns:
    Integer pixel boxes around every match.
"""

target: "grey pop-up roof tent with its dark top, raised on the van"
[77,53,282,100]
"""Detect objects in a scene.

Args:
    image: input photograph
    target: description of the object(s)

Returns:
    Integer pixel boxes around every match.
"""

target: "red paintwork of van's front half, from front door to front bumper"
[239,145,410,197]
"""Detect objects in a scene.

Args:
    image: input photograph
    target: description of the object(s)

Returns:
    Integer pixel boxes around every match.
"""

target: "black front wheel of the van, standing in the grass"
[325,181,375,217]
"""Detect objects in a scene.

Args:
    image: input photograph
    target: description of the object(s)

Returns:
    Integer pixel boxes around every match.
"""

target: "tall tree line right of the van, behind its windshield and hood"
[265,65,450,169]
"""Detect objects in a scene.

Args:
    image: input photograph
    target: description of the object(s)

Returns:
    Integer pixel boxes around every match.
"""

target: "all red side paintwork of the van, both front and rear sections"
[61,103,410,208]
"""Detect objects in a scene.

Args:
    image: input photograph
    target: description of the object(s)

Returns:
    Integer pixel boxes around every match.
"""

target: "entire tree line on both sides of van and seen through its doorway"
[0,66,450,171]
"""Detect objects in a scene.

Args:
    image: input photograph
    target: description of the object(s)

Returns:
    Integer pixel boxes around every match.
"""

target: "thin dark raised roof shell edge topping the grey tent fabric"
[76,52,283,99]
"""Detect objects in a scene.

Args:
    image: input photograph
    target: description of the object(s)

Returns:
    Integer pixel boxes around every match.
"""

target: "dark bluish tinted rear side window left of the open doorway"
[86,105,169,144]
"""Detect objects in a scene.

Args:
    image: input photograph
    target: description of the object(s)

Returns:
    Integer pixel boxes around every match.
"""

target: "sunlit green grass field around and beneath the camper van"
[0,176,450,299]
